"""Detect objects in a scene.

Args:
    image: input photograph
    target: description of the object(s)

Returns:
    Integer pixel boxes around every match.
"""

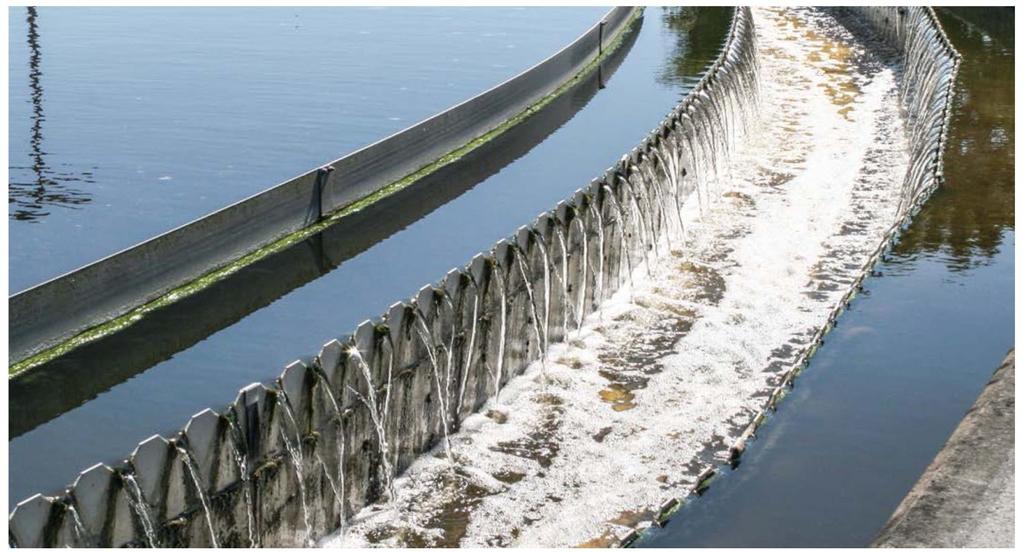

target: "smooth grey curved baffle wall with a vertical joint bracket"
[8,7,638,364]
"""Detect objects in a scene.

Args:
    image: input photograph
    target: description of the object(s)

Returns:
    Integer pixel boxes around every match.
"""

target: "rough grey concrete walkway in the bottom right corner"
[873,350,1016,548]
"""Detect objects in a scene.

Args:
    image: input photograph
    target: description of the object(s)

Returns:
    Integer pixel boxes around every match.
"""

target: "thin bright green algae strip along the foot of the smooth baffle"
[7,8,642,378]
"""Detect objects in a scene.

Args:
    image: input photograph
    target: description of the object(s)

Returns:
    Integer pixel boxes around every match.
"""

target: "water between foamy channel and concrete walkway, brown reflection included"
[639,8,1016,547]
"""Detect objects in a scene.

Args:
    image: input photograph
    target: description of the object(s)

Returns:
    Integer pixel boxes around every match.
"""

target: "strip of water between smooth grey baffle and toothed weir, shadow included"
[8,8,730,501]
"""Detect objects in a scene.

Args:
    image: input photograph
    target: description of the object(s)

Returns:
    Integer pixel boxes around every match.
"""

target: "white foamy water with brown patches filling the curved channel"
[322,9,907,547]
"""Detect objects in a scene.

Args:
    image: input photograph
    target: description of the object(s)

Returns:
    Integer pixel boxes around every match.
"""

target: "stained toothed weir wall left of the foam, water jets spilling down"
[10,8,757,547]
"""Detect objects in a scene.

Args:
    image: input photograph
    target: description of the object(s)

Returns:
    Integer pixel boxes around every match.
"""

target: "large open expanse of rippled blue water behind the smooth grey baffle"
[7,7,608,292]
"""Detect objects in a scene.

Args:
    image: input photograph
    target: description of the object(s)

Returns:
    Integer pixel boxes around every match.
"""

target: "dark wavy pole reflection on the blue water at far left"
[7,7,95,222]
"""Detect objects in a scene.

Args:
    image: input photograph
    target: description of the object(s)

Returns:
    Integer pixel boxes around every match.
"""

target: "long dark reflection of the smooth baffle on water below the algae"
[9,19,641,439]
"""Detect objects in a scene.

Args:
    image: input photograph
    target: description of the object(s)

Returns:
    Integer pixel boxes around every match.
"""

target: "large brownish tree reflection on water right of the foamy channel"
[893,7,1016,271]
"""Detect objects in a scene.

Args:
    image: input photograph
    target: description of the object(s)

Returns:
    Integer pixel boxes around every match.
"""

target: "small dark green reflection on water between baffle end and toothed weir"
[657,6,731,95]
